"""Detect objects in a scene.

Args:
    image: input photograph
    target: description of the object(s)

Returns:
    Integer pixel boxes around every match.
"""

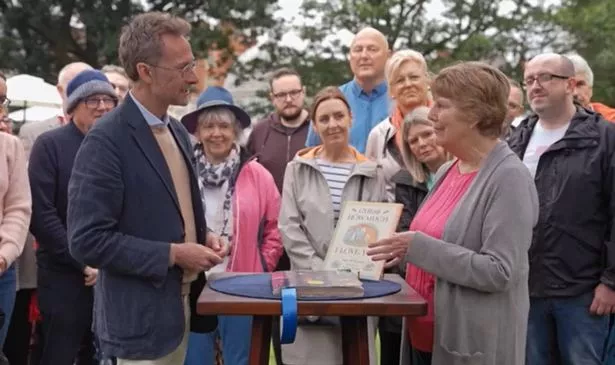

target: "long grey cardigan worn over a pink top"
[402,142,538,365]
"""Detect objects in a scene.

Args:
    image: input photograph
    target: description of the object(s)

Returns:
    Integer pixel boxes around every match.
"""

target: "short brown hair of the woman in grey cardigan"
[431,62,510,138]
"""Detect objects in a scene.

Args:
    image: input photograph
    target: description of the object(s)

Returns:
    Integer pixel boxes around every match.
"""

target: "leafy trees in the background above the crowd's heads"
[0,0,615,105]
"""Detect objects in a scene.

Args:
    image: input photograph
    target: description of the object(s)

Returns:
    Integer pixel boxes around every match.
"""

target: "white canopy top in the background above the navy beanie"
[6,74,62,108]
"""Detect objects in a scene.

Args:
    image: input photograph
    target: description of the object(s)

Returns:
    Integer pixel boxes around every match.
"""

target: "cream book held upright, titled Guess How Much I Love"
[323,201,403,280]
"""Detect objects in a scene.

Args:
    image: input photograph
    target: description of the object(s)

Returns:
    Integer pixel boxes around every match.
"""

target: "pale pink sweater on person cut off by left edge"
[0,133,32,266]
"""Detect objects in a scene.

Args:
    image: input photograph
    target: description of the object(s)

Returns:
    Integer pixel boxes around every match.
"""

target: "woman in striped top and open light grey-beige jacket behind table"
[279,87,386,365]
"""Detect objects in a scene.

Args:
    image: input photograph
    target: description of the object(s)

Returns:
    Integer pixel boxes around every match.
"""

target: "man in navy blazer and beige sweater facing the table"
[68,13,228,365]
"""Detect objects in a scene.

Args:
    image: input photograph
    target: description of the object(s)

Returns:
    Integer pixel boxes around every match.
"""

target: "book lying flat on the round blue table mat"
[271,271,363,298]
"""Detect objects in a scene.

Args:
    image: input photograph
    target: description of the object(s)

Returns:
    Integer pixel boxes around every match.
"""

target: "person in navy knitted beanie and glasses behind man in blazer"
[28,70,118,365]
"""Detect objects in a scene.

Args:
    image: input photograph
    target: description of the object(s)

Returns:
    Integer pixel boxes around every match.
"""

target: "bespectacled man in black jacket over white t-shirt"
[508,54,615,365]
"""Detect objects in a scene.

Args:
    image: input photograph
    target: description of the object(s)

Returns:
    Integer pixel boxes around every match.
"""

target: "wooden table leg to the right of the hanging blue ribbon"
[340,317,369,365]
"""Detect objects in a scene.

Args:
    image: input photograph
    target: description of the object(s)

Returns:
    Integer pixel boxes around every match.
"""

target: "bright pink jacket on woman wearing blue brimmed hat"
[227,160,282,272]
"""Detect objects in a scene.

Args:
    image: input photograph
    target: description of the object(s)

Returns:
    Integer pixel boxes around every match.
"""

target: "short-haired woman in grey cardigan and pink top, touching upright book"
[368,62,538,365]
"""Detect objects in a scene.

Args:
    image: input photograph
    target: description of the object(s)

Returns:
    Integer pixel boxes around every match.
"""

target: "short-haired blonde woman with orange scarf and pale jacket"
[365,50,431,201]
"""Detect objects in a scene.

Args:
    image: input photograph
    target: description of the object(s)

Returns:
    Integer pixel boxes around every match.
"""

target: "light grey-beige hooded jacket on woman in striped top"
[278,146,386,365]
